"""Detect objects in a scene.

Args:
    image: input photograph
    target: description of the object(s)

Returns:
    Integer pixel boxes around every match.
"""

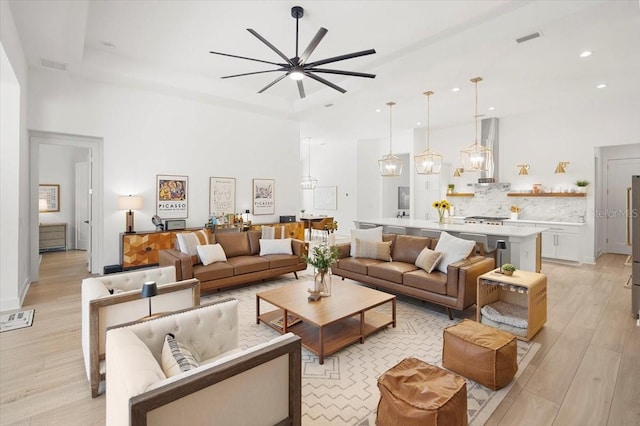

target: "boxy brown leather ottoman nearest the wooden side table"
[442,320,518,390]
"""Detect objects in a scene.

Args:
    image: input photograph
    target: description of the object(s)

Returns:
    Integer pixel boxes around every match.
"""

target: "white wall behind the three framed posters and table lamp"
[28,69,299,272]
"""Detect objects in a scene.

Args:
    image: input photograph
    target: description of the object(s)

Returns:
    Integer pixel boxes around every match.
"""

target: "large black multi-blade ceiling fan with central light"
[209,6,376,98]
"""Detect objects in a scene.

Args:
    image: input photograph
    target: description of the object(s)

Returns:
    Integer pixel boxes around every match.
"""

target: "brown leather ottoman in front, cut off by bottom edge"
[376,358,467,426]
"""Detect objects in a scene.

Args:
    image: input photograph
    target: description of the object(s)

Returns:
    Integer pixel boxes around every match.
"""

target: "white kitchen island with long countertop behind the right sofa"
[354,218,546,272]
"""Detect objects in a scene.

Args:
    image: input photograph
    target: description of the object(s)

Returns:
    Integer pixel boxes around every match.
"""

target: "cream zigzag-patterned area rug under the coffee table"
[201,272,540,426]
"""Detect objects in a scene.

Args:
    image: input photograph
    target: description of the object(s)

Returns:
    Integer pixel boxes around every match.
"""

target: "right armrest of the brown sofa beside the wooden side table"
[447,256,495,310]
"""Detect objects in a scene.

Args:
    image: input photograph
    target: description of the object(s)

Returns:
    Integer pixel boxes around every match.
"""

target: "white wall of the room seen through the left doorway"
[38,144,89,250]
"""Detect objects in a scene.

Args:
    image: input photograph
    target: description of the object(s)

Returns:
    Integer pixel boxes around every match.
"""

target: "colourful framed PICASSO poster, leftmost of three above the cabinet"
[156,175,189,219]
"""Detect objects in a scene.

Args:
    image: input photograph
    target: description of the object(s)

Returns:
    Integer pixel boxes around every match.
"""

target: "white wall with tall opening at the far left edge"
[0,1,33,311]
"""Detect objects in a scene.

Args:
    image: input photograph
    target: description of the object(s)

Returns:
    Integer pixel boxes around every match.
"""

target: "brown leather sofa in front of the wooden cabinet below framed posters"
[158,231,308,291]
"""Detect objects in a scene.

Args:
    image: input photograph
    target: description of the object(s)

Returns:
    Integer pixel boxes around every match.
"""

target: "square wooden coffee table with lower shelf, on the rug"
[256,281,396,364]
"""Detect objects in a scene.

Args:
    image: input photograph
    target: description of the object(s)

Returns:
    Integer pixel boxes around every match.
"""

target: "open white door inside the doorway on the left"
[76,163,91,271]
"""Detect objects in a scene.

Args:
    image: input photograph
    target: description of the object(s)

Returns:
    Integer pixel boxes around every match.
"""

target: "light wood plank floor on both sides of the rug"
[0,251,640,426]
